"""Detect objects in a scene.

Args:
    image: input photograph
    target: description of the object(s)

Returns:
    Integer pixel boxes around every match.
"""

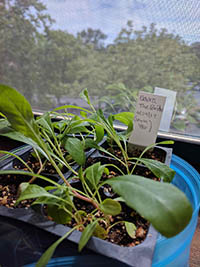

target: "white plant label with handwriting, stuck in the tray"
[129,91,166,147]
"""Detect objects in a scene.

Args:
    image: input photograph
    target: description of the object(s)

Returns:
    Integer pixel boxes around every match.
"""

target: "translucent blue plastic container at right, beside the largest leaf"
[152,155,200,267]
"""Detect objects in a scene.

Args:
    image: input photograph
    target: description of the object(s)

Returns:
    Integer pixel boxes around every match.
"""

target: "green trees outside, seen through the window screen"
[0,0,200,133]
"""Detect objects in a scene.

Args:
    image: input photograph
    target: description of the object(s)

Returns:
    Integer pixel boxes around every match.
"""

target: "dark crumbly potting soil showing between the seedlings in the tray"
[0,147,164,247]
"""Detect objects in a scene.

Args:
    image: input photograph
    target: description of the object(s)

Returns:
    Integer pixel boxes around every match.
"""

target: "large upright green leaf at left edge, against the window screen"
[0,85,39,142]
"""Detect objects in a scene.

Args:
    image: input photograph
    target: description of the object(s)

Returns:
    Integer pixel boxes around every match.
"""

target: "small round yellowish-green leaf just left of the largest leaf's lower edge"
[99,198,122,216]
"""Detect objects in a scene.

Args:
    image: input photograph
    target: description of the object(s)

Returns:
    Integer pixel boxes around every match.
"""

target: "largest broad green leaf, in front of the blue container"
[105,175,193,237]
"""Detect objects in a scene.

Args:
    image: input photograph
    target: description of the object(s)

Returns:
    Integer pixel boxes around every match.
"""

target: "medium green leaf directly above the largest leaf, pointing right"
[134,158,176,183]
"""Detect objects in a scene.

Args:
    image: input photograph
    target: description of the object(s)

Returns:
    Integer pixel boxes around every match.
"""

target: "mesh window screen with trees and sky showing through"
[0,0,200,136]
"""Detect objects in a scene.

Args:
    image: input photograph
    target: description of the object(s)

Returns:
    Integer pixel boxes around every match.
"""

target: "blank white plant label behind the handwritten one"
[154,87,176,132]
